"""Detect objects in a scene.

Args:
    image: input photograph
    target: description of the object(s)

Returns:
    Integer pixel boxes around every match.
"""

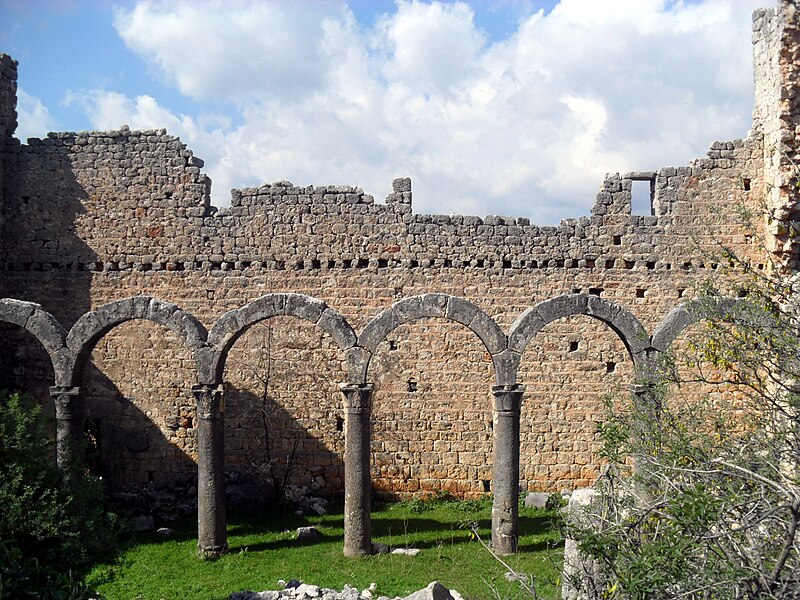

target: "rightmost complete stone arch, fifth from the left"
[507,294,650,384]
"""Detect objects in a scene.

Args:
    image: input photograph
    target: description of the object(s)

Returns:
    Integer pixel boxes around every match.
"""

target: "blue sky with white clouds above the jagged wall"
[0,0,771,224]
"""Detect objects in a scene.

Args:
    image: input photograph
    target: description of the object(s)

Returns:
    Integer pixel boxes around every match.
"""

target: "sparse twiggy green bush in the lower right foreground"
[569,253,800,599]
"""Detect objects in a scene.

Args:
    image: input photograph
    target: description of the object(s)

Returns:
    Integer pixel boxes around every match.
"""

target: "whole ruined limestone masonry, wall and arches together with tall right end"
[0,0,800,556]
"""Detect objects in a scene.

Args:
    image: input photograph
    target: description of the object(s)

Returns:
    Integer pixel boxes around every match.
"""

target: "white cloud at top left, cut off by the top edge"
[114,0,340,102]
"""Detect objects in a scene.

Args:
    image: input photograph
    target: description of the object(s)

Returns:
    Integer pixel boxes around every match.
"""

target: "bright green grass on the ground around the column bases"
[88,499,562,600]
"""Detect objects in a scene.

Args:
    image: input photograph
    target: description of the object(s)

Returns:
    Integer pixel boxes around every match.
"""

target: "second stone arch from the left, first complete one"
[67,296,208,385]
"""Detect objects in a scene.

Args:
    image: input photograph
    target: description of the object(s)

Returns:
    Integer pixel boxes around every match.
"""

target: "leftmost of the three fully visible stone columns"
[192,384,223,559]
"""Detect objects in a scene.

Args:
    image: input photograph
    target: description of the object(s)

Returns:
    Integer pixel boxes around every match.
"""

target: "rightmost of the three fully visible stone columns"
[492,385,525,555]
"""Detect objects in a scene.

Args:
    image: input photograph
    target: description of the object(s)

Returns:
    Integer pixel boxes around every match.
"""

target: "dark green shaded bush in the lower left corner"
[0,392,118,597]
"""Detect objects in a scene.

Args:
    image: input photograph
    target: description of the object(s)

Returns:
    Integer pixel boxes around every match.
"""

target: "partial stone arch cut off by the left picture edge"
[0,298,74,386]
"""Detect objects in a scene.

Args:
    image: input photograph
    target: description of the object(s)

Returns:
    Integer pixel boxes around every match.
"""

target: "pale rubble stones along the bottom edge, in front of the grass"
[229,579,463,600]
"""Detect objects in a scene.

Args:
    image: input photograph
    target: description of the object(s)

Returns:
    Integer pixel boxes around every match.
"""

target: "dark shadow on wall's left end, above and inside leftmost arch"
[0,139,97,434]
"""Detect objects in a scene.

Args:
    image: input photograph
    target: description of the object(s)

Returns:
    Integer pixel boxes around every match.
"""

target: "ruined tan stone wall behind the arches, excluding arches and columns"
[0,3,792,495]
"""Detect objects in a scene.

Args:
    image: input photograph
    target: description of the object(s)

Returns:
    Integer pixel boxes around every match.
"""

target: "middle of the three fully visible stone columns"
[340,383,375,556]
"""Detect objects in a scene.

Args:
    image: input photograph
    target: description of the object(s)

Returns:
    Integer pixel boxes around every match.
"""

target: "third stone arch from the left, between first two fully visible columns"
[203,292,358,384]
